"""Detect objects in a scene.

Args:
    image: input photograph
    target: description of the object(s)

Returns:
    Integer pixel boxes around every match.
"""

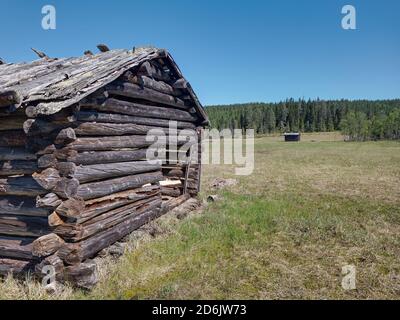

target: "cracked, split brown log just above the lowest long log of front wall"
[54,197,162,242]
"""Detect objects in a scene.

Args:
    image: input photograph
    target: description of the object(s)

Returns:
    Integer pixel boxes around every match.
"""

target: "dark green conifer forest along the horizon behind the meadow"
[207,99,400,141]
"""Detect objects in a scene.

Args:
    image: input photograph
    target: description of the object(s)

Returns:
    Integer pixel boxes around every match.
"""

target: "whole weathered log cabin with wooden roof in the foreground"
[0,48,208,287]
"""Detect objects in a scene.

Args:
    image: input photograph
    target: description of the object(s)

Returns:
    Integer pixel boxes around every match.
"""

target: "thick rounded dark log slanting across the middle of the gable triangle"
[106,82,187,109]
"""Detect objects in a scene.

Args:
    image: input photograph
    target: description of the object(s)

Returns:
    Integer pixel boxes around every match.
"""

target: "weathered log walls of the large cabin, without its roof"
[0,55,205,283]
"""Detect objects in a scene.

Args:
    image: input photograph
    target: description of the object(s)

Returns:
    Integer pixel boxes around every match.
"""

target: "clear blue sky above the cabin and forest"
[0,0,400,105]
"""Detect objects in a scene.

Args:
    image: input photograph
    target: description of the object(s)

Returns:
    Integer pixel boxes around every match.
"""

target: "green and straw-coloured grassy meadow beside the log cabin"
[0,133,400,299]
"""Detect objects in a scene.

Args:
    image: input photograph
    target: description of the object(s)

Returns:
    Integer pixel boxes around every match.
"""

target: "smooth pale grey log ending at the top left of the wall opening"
[58,161,161,184]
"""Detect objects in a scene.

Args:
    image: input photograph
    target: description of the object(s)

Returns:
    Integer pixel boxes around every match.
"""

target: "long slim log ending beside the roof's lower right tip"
[76,111,196,129]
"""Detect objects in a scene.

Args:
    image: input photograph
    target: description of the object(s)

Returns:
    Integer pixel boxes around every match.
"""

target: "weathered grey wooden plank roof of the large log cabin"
[0,48,208,124]
